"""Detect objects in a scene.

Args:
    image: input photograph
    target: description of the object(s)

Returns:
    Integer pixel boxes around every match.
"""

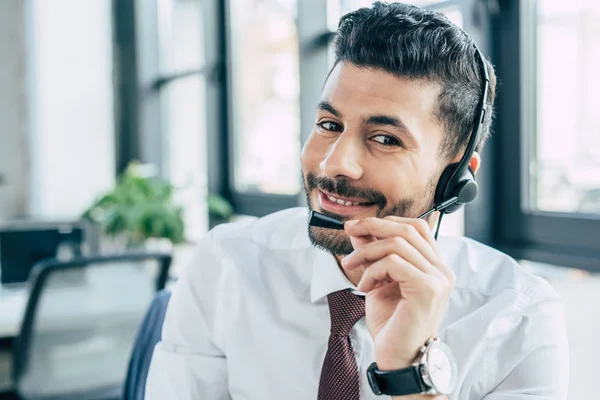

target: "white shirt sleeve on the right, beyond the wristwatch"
[484,281,569,400]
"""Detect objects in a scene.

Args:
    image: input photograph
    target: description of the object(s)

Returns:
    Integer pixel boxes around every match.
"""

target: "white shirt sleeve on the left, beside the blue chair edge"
[145,237,230,400]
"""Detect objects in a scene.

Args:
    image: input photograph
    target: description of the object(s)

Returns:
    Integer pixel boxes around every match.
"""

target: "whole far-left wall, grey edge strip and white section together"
[0,0,115,221]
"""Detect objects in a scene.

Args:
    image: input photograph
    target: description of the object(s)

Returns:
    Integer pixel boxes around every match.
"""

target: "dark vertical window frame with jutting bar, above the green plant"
[113,0,210,176]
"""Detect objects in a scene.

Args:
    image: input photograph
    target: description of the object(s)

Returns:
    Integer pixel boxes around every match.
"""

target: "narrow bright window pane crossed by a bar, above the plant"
[157,0,208,239]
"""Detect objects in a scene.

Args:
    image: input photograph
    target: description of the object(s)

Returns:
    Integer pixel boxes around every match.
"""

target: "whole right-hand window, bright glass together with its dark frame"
[493,0,600,271]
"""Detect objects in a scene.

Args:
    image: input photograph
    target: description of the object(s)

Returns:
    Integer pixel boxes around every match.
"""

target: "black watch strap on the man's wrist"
[367,363,428,396]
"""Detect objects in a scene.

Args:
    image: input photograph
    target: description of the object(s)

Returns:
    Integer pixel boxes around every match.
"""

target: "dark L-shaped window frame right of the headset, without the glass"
[493,0,600,272]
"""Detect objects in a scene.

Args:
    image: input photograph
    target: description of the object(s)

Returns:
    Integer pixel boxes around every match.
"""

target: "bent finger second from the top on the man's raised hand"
[342,236,440,274]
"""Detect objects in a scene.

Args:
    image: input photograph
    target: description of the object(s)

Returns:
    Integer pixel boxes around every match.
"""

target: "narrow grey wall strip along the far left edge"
[0,1,28,221]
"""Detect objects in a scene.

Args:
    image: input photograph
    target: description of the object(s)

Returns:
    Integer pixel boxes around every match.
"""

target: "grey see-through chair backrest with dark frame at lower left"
[13,253,171,399]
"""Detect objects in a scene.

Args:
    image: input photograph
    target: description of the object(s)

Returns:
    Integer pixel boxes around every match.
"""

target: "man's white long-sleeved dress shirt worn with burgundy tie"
[146,208,569,400]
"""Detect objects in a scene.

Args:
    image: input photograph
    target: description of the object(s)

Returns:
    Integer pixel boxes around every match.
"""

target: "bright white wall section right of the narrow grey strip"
[28,0,116,218]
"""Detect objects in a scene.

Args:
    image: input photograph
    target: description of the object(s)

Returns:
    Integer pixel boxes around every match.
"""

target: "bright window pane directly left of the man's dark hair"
[229,0,301,195]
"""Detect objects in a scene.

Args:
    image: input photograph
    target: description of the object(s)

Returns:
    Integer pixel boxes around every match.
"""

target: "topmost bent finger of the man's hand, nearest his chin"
[346,217,443,272]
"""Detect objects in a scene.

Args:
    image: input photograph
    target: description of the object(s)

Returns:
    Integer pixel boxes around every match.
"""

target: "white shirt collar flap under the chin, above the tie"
[310,248,365,303]
